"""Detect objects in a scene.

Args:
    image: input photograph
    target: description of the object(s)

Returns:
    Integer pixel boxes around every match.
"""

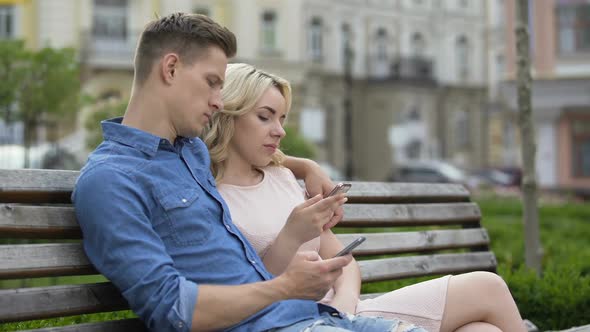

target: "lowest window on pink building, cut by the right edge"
[571,119,590,177]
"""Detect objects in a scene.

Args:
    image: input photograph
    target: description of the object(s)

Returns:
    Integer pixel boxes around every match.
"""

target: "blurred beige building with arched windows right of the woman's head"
[224,0,487,180]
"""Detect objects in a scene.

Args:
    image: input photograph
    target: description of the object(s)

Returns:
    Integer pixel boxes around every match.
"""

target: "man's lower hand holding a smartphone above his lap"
[273,251,352,301]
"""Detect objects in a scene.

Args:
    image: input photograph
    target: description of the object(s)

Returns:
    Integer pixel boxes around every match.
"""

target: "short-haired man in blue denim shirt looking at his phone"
[72,13,426,331]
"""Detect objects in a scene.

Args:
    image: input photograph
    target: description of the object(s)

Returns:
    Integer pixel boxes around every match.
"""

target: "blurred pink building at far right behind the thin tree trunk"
[499,0,590,190]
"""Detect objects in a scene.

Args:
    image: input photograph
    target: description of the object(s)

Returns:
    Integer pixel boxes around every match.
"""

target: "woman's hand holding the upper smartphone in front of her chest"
[281,194,347,244]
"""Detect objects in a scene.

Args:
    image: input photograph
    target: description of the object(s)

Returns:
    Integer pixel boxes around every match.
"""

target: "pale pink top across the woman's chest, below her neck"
[217,166,320,257]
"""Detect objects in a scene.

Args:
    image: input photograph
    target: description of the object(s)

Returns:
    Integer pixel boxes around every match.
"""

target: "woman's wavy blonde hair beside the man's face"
[203,63,291,181]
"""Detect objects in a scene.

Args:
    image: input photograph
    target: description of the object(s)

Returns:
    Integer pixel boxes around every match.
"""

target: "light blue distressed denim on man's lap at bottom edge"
[271,312,427,332]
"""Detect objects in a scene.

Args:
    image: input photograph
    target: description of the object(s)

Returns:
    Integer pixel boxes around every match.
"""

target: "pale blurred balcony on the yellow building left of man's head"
[80,31,140,69]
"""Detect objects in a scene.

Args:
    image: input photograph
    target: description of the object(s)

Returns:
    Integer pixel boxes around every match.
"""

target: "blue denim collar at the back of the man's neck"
[100,117,167,157]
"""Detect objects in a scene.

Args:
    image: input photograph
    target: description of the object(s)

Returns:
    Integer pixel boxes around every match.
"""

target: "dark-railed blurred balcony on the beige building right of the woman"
[369,56,436,83]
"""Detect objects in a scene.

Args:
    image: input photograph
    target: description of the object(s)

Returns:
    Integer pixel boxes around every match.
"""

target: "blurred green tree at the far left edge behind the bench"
[0,41,80,168]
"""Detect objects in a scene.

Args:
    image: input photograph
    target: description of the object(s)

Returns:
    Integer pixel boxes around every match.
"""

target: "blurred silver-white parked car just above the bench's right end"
[388,160,480,187]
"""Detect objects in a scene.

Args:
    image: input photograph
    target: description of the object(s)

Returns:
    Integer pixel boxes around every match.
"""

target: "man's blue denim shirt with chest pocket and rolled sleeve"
[72,118,319,331]
